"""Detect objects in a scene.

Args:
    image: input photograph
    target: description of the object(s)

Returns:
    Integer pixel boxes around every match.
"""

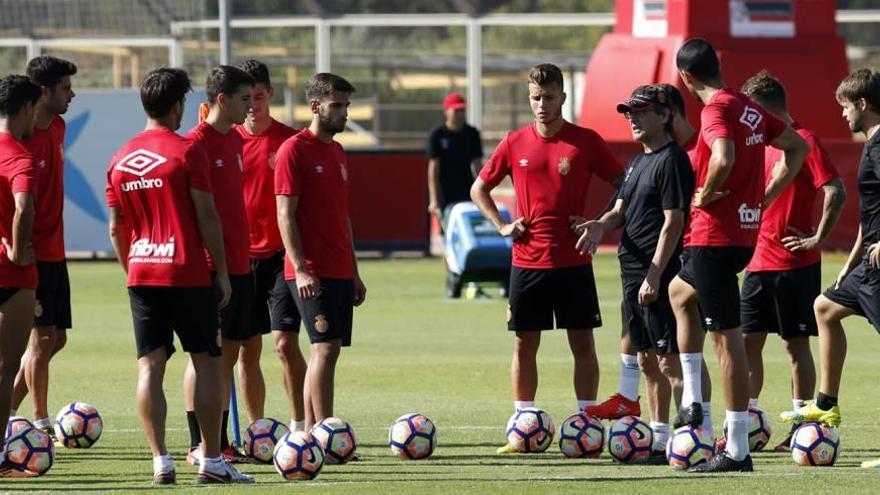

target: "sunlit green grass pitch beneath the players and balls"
[6,254,880,494]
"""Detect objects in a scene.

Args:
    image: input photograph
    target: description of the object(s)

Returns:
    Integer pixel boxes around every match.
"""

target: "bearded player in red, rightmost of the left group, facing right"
[275,73,367,429]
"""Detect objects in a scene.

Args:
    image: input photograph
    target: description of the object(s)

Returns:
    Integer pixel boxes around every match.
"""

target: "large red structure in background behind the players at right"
[578,0,860,249]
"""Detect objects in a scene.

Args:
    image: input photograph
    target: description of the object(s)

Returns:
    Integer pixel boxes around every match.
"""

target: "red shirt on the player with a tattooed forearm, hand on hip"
[746,122,839,272]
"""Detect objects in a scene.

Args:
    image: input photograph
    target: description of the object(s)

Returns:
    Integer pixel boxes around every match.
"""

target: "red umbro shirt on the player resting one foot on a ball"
[684,88,786,247]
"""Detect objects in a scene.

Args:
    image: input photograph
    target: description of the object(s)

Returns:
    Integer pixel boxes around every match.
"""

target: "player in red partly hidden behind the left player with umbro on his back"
[183,65,254,465]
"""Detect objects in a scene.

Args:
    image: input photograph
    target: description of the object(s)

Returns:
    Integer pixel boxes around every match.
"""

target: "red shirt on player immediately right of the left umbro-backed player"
[186,122,251,275]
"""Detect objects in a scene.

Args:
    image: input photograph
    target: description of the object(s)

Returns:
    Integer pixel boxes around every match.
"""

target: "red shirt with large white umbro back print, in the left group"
[106,128,211,287]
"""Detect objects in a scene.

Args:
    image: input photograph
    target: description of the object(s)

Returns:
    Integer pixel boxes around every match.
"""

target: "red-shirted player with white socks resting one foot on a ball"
[669,38,808,472]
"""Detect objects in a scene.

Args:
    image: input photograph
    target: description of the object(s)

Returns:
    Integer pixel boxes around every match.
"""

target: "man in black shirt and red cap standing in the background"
[427,93,483,228]
